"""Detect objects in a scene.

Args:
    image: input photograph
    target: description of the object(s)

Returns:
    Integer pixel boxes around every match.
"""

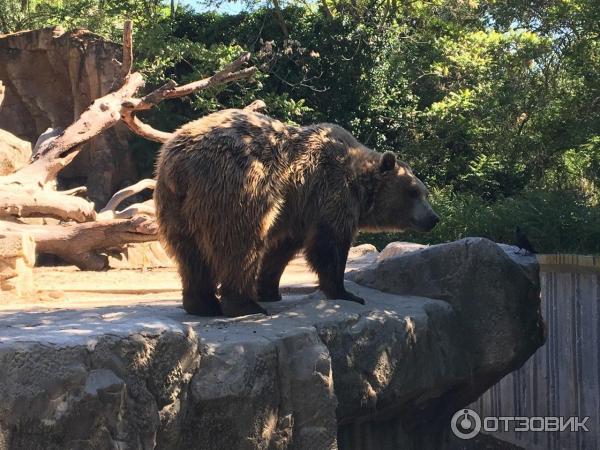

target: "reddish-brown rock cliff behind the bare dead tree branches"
[0,27,138,205]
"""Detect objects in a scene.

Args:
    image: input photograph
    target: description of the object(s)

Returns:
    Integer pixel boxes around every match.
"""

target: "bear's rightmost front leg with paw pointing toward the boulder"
[306,225,365,305]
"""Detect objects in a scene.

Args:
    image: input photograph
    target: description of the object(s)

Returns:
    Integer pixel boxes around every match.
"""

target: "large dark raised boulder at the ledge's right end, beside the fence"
[347,238,545,423]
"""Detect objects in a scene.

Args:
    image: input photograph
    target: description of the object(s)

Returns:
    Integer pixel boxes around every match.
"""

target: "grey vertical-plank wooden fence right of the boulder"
[471,255,600,450]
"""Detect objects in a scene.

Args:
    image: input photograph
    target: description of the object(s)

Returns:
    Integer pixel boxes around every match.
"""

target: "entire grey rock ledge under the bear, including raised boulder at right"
[0,240,543,450]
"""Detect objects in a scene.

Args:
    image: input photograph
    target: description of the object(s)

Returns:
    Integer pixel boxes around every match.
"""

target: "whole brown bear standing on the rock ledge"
[154,109,439,317]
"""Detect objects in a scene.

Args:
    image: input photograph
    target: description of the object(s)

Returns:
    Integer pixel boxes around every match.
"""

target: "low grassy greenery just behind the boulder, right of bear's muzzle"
[357,189,600,253]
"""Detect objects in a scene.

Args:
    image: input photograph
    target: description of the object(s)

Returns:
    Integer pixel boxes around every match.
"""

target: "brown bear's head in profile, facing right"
[360,152,440,231]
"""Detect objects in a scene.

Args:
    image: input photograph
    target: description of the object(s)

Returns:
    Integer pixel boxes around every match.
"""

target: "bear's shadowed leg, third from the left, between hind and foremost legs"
[257,238,302,302]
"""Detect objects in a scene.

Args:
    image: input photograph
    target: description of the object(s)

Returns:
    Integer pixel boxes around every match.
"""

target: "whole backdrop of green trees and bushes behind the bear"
[0,0,600,252]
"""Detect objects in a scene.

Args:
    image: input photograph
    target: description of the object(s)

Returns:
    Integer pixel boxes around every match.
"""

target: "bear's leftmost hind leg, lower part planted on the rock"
[174,240,223,316]
